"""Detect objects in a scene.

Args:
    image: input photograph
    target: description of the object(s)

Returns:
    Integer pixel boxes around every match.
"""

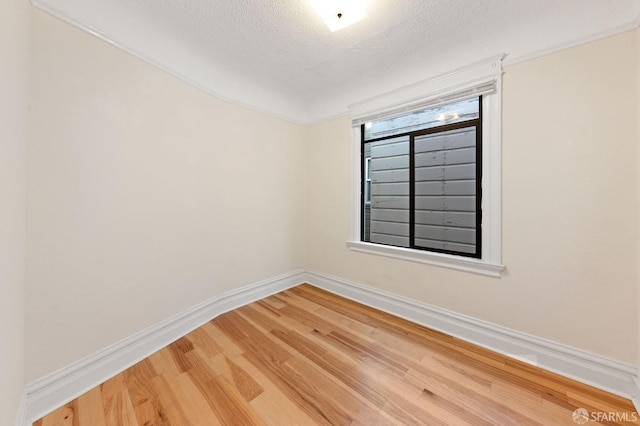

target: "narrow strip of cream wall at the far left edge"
[0,0,32,424]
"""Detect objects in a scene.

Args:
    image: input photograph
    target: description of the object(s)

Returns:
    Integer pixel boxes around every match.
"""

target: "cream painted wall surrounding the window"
[307,32,638,364]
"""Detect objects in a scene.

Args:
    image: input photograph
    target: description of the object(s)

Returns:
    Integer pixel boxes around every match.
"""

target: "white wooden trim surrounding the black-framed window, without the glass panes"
[347,55,504,277]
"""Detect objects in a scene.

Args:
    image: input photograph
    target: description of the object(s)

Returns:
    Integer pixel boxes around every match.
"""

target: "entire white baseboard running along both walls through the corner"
[16,270,640,426]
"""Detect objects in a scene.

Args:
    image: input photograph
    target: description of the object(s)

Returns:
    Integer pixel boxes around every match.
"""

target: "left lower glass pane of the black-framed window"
[363,136,409,247]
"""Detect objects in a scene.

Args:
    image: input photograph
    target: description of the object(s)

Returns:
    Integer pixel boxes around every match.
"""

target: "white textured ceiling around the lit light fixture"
[33,0,640,123]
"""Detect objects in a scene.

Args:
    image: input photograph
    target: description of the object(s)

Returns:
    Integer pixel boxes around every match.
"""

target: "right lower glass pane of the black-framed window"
[414,126,476,254]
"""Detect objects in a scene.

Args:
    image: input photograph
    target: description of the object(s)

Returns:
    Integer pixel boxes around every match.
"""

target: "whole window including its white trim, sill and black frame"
[348,56,503,276]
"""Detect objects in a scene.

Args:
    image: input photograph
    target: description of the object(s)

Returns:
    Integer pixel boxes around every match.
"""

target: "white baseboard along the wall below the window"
[306,271,640,412]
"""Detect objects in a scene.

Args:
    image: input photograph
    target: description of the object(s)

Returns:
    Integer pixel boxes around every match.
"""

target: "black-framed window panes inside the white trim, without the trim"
[361,98,482,258]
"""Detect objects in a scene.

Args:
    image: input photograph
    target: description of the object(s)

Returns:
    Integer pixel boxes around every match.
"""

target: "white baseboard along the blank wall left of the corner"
[23,270,306,426]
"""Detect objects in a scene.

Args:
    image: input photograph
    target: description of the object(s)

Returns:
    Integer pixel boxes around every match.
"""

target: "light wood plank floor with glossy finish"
[35,285,640,426]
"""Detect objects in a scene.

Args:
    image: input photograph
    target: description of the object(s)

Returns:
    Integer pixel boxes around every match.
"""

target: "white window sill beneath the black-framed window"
[347,241,504,278]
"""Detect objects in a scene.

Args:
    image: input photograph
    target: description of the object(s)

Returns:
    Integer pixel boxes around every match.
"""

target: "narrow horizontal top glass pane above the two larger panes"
[364,98,479,141]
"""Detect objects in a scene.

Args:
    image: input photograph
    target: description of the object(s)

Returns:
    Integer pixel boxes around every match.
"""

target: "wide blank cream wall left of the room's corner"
[26,11,308,381]
